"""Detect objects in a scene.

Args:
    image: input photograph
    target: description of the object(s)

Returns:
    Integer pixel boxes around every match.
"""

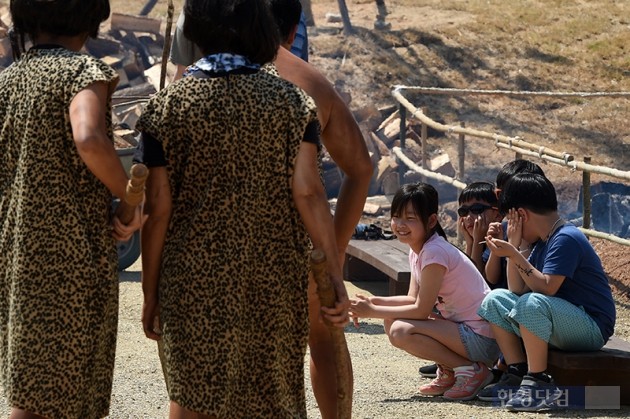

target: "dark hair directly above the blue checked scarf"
[184,0,280,64]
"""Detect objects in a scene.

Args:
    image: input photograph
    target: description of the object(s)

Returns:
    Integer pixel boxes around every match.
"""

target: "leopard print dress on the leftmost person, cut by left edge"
[0,46,118,418]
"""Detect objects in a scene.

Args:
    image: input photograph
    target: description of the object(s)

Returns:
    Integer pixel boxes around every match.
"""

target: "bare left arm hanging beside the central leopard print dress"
[142,167,172,339]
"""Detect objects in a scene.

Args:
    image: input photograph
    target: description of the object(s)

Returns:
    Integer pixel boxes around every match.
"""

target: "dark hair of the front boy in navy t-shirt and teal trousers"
[499,173,558,215]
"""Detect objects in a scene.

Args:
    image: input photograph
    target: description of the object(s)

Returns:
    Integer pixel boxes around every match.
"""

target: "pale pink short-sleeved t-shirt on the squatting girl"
[409,234,494,338]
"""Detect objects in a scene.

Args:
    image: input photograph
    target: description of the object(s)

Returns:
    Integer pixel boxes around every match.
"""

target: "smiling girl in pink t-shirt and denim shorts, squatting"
[350,183,499,400]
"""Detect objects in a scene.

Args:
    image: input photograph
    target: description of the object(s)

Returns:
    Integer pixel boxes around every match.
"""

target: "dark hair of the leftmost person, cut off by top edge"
[10,0,110,55]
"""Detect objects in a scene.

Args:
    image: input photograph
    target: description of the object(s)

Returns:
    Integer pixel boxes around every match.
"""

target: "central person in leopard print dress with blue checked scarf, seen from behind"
[136,0,348,418]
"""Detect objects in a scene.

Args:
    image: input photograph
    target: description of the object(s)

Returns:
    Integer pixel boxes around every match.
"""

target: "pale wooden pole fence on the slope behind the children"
[392,85,630,246]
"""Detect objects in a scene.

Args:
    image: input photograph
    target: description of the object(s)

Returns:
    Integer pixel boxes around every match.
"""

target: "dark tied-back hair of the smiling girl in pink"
[391,182,446,238]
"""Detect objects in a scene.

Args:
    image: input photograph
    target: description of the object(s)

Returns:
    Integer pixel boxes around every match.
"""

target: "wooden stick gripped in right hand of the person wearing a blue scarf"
[311,249,352,419]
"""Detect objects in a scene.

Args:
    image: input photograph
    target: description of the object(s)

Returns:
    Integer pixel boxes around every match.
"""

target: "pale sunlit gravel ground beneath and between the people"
[0,262,630,419]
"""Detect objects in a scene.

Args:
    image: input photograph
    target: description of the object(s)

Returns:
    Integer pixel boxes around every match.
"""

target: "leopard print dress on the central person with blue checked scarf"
[137,71,317,418]
